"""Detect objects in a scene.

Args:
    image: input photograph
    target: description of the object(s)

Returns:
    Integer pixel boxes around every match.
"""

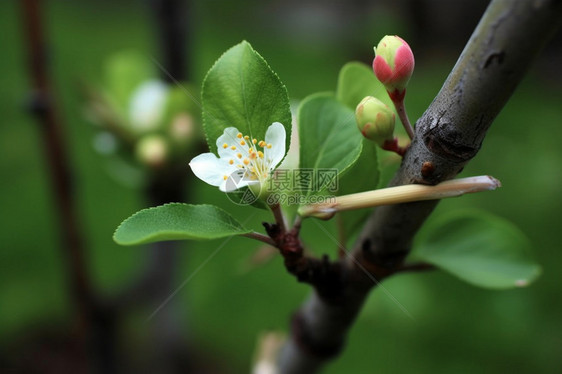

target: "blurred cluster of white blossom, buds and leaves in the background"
[82,50,202,177]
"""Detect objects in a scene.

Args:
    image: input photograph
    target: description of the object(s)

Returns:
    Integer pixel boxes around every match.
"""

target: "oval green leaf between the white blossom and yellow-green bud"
[298,93,363,193]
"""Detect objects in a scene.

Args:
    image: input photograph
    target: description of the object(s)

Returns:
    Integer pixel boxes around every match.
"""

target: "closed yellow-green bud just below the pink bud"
[355,96,395,147]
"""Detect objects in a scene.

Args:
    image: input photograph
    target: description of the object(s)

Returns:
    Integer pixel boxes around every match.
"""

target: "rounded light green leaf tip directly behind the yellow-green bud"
[336,62,388,111]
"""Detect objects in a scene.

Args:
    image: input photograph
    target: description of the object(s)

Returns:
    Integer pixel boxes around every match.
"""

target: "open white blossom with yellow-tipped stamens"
[189,122,286,192]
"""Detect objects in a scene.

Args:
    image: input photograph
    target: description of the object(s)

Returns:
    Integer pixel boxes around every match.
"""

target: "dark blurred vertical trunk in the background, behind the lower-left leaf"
[145,0,192,373]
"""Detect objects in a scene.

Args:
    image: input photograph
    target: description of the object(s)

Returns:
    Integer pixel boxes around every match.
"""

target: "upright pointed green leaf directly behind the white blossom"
[201,41,291,153]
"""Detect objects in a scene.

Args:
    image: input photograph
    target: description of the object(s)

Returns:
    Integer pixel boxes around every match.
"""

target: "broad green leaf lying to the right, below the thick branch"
[412,211,541,289]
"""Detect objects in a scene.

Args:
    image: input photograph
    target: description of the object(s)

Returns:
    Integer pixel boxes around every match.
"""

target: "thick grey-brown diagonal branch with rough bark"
[279,0,562,374]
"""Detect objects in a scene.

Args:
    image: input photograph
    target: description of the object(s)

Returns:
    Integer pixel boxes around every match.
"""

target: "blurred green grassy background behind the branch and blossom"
[0,0,562,374]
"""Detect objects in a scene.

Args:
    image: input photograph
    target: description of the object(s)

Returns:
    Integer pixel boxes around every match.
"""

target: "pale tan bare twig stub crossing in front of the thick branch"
[299,175,501,219]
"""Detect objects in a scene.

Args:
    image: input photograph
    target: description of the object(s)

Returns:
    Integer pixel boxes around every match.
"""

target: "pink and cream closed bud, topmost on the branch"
[373,35,415,101]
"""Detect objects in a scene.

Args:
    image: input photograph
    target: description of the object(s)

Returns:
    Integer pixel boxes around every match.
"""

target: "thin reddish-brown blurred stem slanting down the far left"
[20,0,93,338]
